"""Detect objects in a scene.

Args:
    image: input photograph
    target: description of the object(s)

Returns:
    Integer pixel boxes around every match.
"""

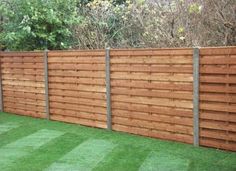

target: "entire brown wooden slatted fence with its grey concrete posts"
[0,47,236,151]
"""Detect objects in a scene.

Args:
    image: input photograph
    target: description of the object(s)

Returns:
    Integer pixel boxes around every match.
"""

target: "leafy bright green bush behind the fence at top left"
[0,0,79,50]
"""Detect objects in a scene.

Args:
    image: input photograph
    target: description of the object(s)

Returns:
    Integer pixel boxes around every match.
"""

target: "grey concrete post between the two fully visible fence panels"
[106,48,112,130]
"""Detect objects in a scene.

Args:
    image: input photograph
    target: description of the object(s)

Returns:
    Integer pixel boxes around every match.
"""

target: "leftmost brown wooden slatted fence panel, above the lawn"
[1,52,45,118]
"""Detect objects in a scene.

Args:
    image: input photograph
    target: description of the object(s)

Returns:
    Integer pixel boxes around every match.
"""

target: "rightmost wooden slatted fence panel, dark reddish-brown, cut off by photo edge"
[200,48,236,151]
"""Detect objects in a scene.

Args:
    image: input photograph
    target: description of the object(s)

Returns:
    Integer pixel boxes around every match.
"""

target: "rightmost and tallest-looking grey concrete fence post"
[193,48,199,146]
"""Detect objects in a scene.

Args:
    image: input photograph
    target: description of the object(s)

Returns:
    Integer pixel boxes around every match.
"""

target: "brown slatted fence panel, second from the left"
[48,50,106,128]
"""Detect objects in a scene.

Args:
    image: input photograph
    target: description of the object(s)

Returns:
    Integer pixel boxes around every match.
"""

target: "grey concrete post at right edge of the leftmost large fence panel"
[44,50,50,120]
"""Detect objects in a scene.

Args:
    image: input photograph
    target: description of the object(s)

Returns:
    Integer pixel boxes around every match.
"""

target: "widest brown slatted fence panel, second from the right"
[110,49,193,143]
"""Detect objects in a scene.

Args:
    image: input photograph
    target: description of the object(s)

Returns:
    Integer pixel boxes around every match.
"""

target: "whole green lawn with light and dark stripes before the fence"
[0,113,236,171]
